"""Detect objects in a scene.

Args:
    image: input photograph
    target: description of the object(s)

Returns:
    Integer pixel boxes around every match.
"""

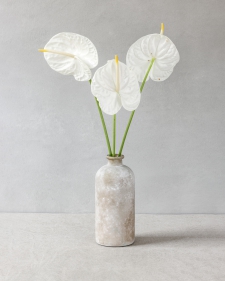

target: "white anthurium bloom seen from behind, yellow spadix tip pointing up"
[126,24,180,82]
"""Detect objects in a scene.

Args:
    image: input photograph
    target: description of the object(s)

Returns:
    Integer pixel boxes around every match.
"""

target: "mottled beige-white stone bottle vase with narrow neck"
[95,156,135,246]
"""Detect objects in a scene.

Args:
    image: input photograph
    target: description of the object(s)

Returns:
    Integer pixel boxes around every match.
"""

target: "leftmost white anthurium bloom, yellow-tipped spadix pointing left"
[39,32,98,81]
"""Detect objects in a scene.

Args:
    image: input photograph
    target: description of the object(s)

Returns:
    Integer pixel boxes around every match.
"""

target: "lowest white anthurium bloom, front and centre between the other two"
[91,60,141,115]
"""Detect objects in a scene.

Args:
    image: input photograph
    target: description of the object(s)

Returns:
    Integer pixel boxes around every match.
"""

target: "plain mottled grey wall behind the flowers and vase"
[0,0,225,213]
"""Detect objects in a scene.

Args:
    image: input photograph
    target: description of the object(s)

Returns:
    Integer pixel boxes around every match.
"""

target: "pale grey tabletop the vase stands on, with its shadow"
[0,214,225,281]
